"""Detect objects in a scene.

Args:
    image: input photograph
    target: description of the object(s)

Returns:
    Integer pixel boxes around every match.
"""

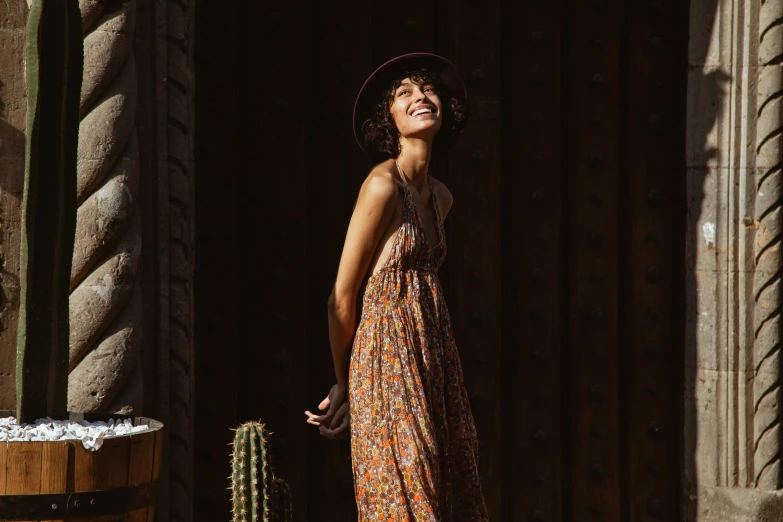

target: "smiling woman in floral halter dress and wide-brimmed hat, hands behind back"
[305,53,487,522]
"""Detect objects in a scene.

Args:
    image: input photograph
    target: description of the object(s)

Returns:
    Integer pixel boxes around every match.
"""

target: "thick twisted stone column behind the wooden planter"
[68,0,143,412]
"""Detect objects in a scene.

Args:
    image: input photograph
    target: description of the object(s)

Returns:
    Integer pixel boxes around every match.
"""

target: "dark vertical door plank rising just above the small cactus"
[238,5,310,522]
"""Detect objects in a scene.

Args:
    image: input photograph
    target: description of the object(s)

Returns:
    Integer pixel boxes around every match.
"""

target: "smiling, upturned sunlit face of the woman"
[391,78,443,140]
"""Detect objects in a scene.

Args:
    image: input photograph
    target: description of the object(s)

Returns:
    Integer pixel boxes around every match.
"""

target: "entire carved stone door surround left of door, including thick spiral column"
[0,0,194,522]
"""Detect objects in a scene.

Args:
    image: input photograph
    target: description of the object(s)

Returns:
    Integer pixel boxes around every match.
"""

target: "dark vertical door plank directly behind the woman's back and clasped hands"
[310,0,373,522]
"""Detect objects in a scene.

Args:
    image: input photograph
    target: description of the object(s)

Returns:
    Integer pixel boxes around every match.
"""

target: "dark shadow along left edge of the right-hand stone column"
[681,0,732,522]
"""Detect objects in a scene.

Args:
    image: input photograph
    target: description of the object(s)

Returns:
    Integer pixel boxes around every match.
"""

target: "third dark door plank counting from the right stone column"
[500,1,568,522]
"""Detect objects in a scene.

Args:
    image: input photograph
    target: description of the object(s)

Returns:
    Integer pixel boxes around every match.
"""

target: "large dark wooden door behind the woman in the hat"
[195,0,687,522]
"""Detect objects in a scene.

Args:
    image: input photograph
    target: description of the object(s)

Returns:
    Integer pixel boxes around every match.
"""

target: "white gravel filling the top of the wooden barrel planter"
[0,417,149,451]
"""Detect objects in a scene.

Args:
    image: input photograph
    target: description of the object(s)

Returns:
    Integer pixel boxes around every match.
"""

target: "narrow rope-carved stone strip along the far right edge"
[753,0,783,490]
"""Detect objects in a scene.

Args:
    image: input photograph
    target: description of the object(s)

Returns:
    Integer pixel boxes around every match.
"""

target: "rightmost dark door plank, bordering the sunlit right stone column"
[625,2,686,522]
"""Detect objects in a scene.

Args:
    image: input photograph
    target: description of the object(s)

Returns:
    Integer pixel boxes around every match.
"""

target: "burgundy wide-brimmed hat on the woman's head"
[353,53,468,154]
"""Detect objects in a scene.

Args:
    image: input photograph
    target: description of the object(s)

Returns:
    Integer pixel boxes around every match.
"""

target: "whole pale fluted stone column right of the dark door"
[683,0,783,522]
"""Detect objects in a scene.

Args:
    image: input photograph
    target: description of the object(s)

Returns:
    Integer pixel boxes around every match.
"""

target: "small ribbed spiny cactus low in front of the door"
[230,422,292,522]
